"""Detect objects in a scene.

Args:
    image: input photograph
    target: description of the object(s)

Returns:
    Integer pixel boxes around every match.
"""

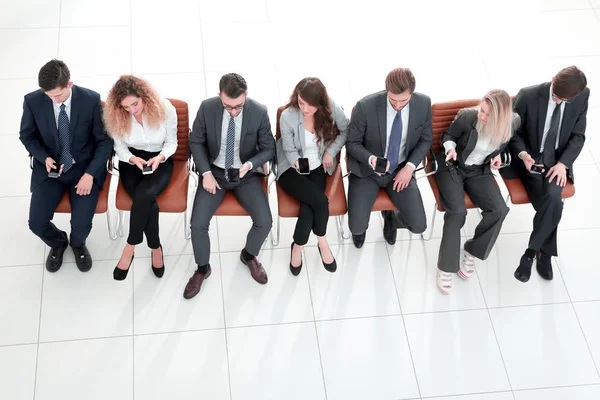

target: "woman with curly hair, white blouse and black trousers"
[104,75,177,281]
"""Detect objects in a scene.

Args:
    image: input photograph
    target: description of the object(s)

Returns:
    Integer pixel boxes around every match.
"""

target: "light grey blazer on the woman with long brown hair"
[277,100,349,179]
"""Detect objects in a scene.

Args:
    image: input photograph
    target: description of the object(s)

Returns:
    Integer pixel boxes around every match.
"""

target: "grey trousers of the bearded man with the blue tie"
[348,167,427,235]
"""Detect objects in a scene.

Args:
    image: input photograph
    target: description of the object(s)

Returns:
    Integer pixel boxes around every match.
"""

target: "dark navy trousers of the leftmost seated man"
[29,164,100,248]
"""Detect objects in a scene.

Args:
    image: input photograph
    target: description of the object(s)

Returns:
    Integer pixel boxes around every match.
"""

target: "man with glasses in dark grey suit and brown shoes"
[183,73,275,299]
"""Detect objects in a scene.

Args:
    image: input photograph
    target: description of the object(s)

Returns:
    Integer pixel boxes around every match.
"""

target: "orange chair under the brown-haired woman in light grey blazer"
[273,106,350,246]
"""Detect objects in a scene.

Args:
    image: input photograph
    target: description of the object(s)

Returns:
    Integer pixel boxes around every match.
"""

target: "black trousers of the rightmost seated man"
[519,163,563,256]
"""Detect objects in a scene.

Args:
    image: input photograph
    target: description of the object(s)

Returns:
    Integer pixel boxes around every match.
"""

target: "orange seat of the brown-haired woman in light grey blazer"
[276,163,348,218]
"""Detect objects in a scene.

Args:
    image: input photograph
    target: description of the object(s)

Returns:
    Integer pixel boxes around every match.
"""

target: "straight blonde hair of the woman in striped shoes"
[476,89,513,148]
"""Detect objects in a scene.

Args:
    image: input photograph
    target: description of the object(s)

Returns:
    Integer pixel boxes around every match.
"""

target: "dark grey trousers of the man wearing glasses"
[192,166,273,265]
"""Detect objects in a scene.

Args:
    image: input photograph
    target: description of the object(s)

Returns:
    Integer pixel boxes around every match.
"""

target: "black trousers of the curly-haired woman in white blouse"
[119,147,173,249]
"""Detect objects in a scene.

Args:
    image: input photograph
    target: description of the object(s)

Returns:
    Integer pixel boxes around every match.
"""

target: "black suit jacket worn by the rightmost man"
[502,82,590,180]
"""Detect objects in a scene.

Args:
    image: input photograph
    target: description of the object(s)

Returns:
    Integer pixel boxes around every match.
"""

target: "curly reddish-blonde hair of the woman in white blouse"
[104,75,166,138]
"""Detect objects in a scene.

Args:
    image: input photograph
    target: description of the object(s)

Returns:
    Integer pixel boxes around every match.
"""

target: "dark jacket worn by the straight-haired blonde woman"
[441,108,521,169]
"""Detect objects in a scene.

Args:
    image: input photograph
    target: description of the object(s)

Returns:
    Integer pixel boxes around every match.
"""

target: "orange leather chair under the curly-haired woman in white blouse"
[116,99,197,239]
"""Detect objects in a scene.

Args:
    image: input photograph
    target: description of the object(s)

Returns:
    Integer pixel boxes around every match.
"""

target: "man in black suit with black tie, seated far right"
[502,67,590,282]
